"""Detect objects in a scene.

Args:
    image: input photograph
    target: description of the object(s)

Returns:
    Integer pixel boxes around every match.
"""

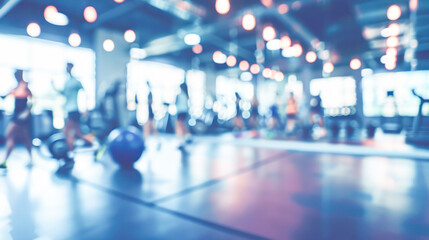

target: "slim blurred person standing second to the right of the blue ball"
[176,83,191,150]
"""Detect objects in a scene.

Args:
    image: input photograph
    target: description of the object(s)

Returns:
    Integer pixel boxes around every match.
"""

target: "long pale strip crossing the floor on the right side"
[194,137,429,161]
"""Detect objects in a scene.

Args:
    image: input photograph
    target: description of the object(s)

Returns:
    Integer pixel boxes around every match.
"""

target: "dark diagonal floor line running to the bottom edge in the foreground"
[63,176,269,240]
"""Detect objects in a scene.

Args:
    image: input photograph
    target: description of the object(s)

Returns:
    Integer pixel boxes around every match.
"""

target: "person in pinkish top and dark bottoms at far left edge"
[0,69,33,169]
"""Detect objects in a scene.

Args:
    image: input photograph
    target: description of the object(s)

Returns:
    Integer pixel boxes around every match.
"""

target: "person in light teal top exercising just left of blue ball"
[54,63,92,162]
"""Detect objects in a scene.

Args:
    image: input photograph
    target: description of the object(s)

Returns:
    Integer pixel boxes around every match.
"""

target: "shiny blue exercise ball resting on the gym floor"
[108,127,145,167]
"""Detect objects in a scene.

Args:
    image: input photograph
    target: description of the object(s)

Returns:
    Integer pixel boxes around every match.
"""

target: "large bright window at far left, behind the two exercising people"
[0,34,95,128]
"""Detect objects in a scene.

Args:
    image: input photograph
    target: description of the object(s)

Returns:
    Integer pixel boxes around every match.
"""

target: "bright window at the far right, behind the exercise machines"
[362,71,429,116]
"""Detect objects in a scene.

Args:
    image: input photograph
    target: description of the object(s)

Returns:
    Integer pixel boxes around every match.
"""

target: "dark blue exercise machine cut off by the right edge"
[405,89,429,146]
